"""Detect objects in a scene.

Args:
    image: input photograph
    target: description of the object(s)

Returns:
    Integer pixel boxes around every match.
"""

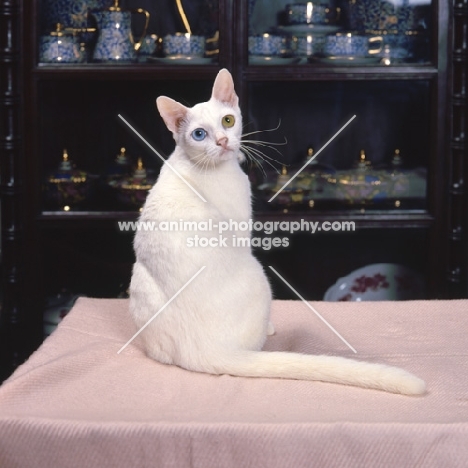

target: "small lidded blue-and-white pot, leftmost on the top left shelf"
[39,23,86,63]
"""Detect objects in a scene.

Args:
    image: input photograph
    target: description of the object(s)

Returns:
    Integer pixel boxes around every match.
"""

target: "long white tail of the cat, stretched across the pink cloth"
[210,351,426,395]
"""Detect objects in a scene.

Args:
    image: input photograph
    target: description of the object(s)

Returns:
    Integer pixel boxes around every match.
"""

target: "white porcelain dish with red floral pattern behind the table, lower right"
[323,263,424,302]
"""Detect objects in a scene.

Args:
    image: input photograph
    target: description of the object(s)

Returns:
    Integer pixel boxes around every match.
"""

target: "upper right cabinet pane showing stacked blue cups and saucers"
[248,0,432,66]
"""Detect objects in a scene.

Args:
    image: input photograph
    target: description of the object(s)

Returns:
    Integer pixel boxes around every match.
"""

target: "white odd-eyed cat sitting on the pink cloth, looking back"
[130,70,425,395]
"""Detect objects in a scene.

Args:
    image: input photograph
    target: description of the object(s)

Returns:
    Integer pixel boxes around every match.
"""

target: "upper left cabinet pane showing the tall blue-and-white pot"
[37,0,219,65]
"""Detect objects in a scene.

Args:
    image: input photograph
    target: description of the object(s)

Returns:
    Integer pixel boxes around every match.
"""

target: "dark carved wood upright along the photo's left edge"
[0,0,25,381]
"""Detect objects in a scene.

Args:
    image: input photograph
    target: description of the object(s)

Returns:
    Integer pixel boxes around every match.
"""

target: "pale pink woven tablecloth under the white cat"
[0,298,468,468]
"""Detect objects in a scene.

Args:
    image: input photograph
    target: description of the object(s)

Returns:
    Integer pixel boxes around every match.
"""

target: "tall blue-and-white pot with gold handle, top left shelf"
[92,0,150,62]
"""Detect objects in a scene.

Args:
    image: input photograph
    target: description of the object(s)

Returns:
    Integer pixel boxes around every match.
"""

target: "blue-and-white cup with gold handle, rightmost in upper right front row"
[323,32,382,57]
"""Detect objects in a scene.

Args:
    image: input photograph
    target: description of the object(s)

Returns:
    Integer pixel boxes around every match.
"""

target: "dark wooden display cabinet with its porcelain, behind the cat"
[0,0,468,375]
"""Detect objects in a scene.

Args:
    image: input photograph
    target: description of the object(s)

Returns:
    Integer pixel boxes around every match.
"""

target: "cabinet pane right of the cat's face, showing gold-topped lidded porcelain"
[246,80,431,212]
